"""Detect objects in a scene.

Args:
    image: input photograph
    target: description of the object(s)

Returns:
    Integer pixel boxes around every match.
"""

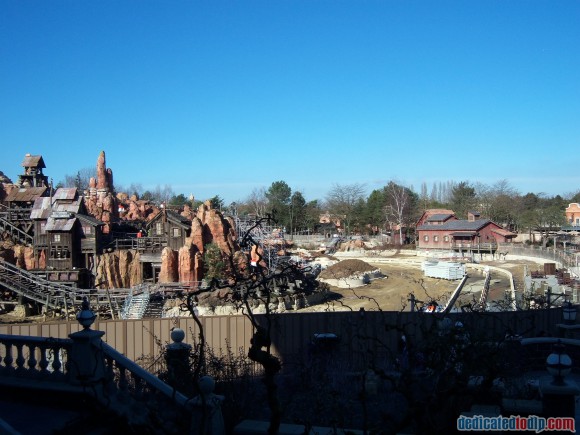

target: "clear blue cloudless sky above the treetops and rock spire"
[0,0,580,203]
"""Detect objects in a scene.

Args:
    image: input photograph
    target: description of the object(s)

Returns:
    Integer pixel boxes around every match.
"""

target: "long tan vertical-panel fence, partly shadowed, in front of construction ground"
[0,308,562,372]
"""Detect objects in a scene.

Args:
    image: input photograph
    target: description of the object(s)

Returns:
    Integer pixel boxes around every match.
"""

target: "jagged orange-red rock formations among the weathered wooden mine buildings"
[0,151,247,288]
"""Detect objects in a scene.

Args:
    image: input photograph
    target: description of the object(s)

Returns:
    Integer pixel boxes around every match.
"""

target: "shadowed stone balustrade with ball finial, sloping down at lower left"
[0,300,191,433]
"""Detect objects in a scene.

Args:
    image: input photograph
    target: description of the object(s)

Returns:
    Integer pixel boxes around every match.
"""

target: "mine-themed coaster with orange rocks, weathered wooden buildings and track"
[0,152,326,319]
